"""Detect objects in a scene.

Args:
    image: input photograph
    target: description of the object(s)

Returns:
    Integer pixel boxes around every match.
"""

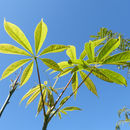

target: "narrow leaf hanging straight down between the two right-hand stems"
[72,72,78,97]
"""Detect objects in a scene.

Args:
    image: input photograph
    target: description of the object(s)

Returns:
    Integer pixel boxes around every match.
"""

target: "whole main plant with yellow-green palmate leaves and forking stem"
[0,20,130,130]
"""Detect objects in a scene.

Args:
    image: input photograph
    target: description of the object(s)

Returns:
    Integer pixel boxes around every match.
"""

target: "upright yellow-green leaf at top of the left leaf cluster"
[34,19,47,55]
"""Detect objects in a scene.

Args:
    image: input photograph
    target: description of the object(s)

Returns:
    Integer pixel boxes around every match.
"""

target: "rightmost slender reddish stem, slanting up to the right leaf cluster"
[49,69,93,121]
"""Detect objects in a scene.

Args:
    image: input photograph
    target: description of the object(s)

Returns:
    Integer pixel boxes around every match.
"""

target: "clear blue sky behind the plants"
[0,0,130,130]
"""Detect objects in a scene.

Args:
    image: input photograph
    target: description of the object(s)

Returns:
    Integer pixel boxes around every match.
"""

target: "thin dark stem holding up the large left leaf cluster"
[34,57,46,118]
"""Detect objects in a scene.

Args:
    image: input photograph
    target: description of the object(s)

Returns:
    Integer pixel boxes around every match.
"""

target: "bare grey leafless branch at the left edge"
[0,68,22,117]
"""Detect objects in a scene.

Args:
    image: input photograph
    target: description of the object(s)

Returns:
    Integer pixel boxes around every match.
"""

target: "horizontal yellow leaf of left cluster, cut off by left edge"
[0,44,31,56]
